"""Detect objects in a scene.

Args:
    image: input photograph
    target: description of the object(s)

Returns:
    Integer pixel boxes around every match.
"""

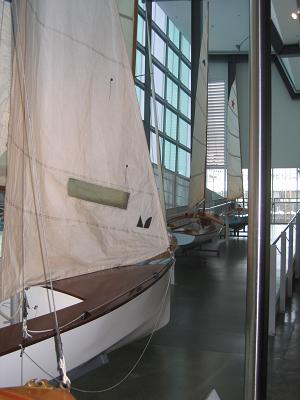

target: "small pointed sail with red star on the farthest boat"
[227,80,243,200]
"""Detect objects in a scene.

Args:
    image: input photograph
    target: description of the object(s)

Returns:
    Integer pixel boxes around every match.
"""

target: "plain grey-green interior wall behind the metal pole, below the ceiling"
[237,63,300,168]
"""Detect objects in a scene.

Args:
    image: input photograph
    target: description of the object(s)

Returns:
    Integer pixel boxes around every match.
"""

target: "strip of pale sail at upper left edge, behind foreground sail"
[0,0,12,185]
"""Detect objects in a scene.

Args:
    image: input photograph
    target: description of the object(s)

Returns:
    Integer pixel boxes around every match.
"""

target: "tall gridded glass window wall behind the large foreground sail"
[135,0,191,208]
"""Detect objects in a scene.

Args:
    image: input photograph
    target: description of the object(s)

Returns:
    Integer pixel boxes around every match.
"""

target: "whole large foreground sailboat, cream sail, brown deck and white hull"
[0,0,174,386]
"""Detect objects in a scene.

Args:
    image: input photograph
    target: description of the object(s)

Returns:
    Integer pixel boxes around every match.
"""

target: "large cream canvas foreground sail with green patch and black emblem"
[0,0,169,299]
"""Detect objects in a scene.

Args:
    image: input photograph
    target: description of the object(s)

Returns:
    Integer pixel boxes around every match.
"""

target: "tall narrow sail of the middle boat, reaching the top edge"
[189,1,208,207]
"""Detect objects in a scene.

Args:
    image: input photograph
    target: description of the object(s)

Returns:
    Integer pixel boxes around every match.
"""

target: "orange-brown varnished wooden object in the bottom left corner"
[0,379,75,400]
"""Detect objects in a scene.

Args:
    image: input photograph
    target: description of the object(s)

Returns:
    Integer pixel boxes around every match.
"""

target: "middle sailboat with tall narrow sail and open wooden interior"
[168,1,223,247]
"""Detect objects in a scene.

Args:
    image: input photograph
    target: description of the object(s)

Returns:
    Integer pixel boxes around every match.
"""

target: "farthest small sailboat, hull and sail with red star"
[226,79,248,230]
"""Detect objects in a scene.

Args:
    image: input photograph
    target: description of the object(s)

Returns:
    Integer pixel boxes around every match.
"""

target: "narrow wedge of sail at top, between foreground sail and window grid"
[117,0,136,67]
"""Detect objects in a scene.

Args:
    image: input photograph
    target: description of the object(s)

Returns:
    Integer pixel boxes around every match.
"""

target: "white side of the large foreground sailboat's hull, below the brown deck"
[0,270,171,386]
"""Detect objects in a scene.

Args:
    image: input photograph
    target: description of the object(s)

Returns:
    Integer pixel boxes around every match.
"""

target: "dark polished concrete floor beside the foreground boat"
[73,238,300,400]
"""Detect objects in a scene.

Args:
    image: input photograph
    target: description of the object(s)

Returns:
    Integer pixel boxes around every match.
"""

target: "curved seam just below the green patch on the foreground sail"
[7,198,163,239]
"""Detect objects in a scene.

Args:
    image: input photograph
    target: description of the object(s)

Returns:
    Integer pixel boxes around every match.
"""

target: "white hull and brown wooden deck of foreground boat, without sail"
[0,259,174,386]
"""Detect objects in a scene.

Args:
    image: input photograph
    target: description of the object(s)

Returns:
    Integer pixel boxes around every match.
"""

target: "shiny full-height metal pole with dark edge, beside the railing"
[244,0,271,400]
